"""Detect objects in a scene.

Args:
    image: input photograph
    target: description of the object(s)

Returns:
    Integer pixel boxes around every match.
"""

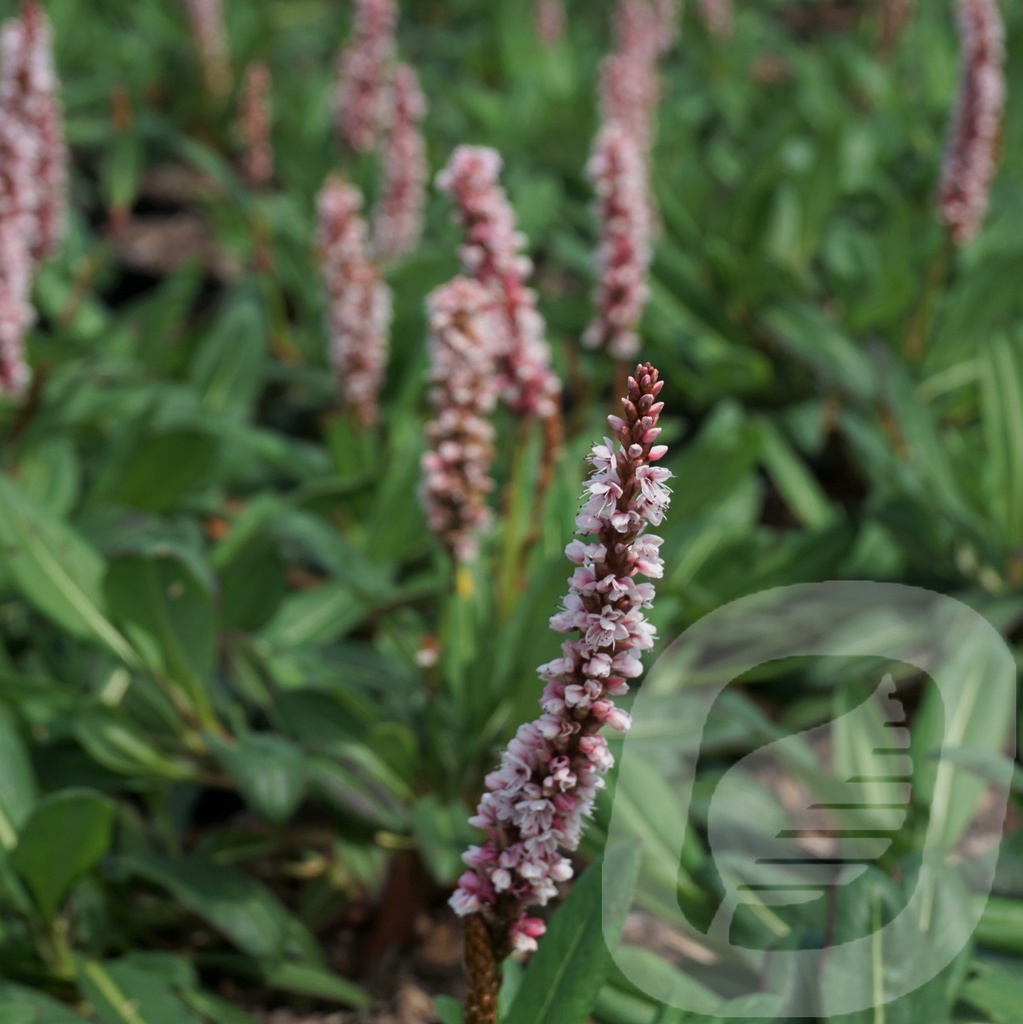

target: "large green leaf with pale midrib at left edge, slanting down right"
[0,473,138,666]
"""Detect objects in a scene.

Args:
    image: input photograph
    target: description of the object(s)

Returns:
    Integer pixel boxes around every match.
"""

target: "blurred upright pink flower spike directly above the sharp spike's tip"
[583,122,650,358]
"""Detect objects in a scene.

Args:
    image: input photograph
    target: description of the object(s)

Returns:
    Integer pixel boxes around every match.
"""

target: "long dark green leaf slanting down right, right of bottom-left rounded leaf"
[123,856,299,959]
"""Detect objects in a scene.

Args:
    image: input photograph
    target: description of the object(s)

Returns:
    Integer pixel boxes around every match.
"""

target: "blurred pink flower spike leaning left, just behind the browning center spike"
[437,145,561,418]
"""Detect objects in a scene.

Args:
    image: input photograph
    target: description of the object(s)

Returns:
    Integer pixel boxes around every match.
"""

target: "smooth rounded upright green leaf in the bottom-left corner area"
[11,790,115,920]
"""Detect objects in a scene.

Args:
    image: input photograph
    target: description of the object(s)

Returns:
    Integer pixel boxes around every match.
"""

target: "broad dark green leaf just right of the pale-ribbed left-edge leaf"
[105,553,216,725]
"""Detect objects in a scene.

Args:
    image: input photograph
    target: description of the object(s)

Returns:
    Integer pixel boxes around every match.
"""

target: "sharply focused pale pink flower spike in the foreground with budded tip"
[451,364,671,950]
